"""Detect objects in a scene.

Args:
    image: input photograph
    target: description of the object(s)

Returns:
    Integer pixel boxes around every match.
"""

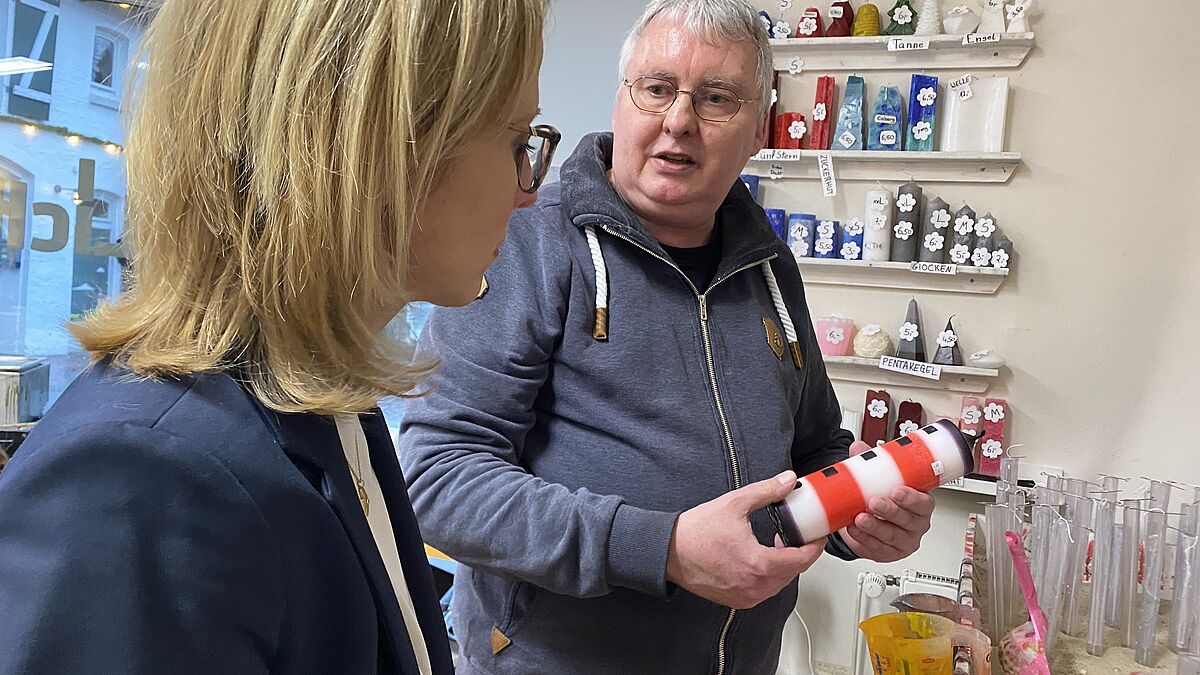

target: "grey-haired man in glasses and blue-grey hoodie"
[400,0,932,675]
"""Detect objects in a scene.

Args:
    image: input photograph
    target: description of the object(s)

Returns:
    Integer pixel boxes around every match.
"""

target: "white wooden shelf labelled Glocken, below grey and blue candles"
[796,258,1009,295]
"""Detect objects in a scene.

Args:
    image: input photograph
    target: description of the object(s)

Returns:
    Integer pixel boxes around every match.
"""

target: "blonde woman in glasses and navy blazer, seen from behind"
[0,0,557,674]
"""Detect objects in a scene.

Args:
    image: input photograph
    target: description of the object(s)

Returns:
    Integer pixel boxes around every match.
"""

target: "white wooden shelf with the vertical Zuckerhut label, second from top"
[743,150,1021,183]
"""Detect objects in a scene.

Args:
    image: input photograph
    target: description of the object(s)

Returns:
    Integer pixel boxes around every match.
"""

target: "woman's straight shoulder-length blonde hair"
[72,0,546,413]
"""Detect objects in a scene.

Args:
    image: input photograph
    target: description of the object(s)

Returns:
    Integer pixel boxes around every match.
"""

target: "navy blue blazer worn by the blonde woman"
[0,366,454,675]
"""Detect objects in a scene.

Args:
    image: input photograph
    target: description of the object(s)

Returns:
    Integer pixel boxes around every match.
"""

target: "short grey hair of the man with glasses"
[617,0,775,114]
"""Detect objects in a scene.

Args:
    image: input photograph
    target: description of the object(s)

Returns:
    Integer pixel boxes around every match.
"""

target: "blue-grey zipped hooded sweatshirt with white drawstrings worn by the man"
[400,133,853,675]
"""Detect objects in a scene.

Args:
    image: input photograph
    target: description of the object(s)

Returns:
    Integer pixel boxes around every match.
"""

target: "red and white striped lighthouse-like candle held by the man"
[767,419,976,546]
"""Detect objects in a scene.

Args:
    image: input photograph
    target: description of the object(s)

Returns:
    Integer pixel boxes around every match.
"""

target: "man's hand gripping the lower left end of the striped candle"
[667,471,825,609]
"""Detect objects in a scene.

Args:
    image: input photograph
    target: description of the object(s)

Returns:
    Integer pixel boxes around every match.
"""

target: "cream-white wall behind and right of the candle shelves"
[755,0,1200,665]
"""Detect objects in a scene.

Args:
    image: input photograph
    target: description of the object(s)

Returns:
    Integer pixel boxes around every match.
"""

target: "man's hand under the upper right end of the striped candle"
[841,488,934,562]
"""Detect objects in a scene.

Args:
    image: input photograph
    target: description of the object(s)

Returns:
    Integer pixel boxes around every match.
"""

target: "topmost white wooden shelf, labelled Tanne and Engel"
[770,32,1033,73]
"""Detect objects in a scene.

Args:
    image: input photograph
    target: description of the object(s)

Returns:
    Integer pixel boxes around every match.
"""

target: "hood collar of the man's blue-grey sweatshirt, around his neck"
[559,132,784,280]
